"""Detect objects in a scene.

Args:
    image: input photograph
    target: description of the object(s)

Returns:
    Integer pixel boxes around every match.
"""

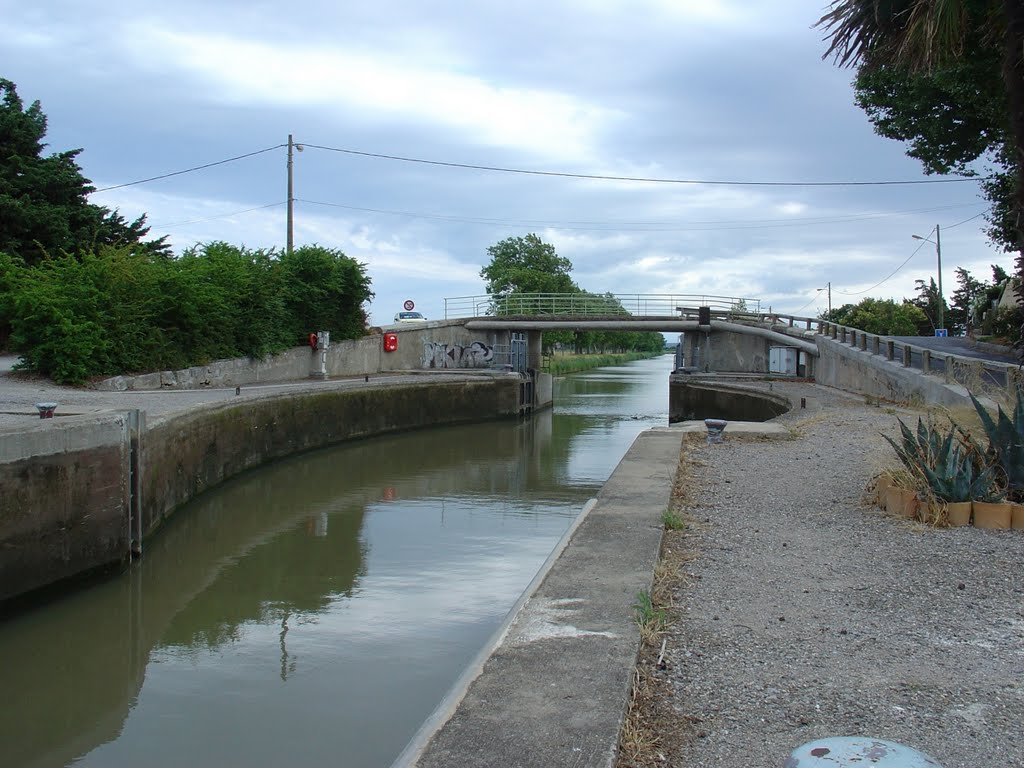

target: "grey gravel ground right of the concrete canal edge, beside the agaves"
[662,386,1024,768]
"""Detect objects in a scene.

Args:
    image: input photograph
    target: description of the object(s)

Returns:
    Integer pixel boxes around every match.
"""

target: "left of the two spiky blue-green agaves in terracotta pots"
[883,419,1000,502]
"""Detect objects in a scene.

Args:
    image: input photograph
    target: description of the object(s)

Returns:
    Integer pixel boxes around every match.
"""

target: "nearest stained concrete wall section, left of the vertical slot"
[0,414,130,601]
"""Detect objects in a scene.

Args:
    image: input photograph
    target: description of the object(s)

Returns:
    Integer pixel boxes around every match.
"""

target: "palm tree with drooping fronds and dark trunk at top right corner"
[818,0,1024,309]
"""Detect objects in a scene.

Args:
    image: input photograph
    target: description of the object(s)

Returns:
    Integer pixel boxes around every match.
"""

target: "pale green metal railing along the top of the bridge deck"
[444,293,761,319]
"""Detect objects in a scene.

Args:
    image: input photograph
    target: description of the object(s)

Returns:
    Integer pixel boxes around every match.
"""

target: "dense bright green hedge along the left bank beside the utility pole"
[0,243,373,383]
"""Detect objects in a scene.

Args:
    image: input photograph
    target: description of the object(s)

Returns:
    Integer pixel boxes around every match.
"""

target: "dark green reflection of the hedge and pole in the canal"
[161,506,366,651]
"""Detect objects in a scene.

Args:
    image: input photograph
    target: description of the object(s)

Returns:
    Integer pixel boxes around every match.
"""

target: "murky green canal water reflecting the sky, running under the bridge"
[0,356,672,768]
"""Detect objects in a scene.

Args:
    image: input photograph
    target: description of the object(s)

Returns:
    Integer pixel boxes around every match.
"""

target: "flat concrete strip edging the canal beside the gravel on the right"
[396,428,683,768]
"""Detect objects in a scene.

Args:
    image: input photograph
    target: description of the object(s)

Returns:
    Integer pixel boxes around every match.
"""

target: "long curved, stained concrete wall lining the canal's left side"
[0,375,521,602]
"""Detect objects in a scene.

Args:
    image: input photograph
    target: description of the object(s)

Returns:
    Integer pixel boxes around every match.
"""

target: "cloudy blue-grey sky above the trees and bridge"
[0,0,1012,324]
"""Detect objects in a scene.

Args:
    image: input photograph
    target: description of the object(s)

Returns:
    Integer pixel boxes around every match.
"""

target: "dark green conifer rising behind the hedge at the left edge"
[0,78,170,265]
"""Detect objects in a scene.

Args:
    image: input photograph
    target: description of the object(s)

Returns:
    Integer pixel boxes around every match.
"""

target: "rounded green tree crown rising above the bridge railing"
[480,233,580,296]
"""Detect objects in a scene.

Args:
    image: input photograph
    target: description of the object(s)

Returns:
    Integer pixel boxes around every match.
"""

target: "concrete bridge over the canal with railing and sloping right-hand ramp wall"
[444,293,1024,408]
